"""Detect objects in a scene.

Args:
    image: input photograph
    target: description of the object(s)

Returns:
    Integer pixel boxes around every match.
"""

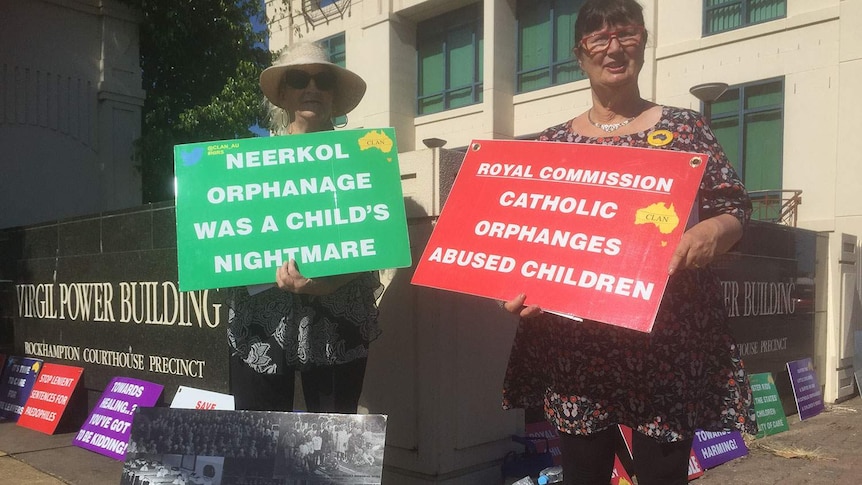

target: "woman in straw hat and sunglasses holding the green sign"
[228,43,381,413]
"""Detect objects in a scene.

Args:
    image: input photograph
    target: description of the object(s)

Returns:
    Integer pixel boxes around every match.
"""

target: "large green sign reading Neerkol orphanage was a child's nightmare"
[174,128,411,291]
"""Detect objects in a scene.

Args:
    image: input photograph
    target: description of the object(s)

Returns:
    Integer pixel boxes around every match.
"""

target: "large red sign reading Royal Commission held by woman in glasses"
[412,140,707,332]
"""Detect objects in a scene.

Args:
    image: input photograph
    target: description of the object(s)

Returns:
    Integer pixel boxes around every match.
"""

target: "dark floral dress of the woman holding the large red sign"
[503,107,757,442]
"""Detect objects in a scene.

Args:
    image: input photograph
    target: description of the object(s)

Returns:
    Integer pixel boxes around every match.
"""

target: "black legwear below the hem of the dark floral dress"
[560,426,692,485]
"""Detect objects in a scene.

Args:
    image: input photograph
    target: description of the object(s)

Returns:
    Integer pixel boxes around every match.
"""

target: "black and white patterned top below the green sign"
[228,273,381,374]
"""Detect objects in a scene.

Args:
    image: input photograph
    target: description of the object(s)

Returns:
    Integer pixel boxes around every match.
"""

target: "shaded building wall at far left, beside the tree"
[0,0,144,228]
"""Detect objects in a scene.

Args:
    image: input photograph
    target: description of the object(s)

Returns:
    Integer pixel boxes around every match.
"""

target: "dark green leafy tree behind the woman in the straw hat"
[125,0,271,202]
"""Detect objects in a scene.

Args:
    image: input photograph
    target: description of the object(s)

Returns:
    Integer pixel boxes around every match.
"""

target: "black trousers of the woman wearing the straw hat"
[230,356,368,414]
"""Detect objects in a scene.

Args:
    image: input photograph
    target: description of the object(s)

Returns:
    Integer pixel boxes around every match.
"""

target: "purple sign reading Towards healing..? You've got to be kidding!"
[72,377,163,460]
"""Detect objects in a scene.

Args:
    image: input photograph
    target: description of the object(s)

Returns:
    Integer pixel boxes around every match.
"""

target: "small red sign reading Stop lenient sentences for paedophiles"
[18,363,84,434]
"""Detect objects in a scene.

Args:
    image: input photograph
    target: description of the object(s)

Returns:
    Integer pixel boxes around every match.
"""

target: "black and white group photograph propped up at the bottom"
[122,408,386,485]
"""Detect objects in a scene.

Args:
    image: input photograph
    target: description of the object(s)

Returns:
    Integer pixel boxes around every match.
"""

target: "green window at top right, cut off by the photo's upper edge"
[703,0,787,35]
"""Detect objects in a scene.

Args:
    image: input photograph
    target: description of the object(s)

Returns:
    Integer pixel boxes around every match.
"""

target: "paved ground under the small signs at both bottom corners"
[0,397,862,485]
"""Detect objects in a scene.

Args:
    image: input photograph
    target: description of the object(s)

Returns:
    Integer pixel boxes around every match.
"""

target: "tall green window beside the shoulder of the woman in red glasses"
[710,79,784,199]
